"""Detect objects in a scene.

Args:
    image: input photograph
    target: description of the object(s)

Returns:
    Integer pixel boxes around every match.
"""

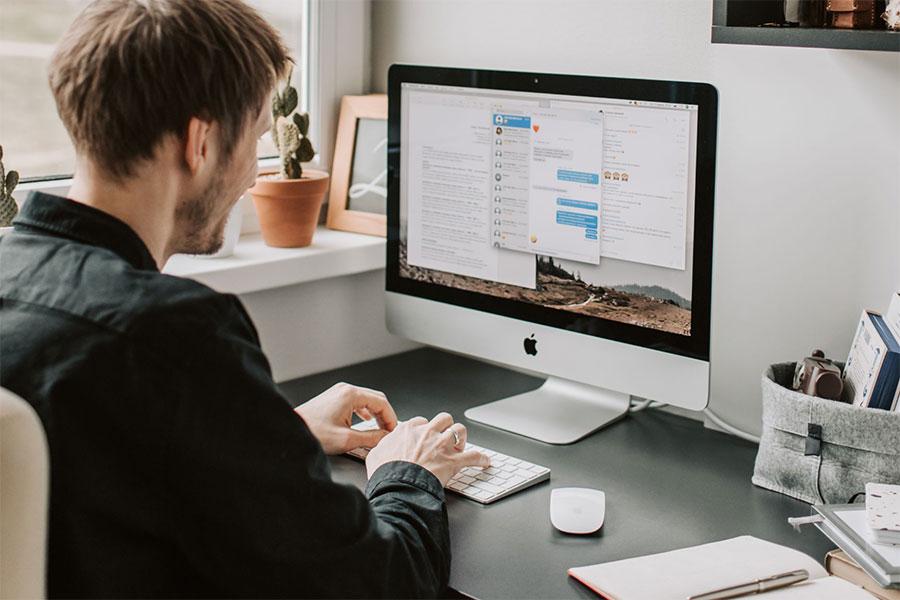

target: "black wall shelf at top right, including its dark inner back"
[712,0,900,52]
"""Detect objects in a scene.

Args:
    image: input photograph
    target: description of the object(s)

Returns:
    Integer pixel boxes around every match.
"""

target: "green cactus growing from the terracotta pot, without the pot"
[272,69,316,179]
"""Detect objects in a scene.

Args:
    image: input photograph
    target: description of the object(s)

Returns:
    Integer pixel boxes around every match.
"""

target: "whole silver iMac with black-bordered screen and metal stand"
[386,65,717,444]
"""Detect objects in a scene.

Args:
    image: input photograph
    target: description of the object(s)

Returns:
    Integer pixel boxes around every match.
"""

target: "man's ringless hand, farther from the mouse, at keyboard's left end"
[294,383,397,454]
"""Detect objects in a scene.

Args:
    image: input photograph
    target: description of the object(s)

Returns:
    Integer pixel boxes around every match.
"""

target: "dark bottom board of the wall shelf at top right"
[712,25,900,52]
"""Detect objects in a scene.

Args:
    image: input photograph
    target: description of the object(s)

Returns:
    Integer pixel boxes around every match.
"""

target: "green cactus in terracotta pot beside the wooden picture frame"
[250,73,328,248]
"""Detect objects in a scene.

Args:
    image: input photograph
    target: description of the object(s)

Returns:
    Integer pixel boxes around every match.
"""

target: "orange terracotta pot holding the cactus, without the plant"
[250,169,328,248]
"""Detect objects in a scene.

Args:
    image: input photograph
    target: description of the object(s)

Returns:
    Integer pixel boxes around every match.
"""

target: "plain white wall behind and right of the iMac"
[371,0,900,432]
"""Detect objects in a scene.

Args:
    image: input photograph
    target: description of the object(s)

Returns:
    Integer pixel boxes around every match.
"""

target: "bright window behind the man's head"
[0,0,310,181]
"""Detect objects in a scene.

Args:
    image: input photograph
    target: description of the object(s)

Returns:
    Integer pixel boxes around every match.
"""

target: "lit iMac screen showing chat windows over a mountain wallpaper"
[390,69,708,356]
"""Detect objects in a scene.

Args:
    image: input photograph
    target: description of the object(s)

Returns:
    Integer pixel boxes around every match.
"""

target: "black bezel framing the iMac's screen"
[385,65,718,361]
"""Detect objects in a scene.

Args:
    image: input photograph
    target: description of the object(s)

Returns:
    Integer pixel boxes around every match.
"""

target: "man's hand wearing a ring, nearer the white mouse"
[366,413,491,486]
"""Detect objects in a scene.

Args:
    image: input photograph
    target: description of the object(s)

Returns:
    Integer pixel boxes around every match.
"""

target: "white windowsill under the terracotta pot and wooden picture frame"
[163,227,385,294]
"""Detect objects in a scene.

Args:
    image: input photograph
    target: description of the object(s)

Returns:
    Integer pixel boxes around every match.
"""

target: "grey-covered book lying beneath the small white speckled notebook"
[813,504,900,589]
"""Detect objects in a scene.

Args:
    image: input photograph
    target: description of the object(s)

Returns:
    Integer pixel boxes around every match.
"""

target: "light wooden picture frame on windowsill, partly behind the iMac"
[327,94,387,237]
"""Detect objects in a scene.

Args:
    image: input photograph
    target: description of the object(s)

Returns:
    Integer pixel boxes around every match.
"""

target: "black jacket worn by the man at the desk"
[0,194,450,597]
